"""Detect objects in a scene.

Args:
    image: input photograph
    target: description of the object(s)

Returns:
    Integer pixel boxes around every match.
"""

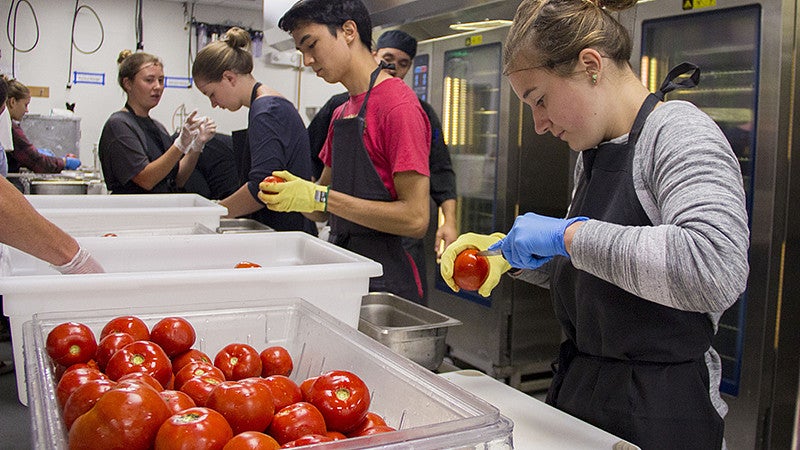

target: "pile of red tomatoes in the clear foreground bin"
[46,316,394,450]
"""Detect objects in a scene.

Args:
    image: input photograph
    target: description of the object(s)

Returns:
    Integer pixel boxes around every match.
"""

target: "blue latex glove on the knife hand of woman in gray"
[489,213,589,269]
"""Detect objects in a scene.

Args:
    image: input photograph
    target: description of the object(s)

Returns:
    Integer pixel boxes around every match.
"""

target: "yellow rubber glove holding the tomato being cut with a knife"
[439,233,511,297]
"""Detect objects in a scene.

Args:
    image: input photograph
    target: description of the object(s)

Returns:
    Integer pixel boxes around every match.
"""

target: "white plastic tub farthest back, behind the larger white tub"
[26,194,228,235]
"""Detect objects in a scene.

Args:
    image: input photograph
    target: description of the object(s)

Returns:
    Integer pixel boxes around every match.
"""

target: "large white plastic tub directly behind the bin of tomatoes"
[0,232,383,403]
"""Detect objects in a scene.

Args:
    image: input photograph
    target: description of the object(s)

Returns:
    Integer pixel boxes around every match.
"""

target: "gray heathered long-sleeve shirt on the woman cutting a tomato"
[518,100,749,327]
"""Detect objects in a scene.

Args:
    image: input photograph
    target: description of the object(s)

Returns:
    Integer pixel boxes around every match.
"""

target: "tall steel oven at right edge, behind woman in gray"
[620,0,800,448]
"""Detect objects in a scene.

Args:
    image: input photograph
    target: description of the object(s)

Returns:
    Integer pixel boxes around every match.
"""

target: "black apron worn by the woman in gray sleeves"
[547,63,724,449]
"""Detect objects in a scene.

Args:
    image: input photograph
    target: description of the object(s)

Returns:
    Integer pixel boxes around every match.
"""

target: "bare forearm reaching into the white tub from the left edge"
[0,177,79,266]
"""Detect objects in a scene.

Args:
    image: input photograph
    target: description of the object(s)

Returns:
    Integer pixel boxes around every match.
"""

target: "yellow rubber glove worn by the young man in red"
[258,170,330,212]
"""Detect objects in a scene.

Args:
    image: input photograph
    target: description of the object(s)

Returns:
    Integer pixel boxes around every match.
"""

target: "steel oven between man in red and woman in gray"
[407,25,571,390]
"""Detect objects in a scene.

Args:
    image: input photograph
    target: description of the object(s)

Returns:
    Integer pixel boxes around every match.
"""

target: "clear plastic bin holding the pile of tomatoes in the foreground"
[24,297,513,450]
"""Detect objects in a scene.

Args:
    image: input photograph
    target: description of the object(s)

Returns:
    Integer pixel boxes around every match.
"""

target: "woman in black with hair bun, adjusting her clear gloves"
[98,50,217,194]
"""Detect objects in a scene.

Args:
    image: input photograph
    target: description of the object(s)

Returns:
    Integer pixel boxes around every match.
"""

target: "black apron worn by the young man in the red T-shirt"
[329,63,422,303]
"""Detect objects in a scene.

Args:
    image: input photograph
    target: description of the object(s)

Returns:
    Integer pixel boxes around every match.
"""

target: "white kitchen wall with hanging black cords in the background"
[0,0,344,165]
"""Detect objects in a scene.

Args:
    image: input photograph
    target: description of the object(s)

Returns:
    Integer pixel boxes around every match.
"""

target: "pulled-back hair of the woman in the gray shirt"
[503,0,637,76]
